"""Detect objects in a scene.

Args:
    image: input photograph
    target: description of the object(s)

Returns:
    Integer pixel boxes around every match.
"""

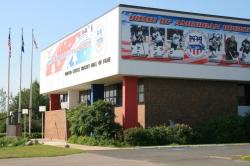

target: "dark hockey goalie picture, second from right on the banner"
[225,35,239,63]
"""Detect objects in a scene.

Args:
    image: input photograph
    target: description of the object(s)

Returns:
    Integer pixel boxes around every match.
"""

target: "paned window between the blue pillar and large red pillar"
[104,84,122,106]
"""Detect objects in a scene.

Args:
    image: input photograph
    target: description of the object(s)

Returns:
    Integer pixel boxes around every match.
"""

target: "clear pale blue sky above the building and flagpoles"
[0,0,250,94]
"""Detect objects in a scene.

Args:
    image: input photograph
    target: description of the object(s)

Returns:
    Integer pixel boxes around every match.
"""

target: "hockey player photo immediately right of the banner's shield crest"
[208,33,223,62]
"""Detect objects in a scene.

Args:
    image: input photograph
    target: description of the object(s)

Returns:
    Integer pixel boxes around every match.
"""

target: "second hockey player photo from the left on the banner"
[150,27,165,57]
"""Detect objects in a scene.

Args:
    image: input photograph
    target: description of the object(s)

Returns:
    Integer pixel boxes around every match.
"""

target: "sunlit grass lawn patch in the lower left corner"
[0,145,83,159]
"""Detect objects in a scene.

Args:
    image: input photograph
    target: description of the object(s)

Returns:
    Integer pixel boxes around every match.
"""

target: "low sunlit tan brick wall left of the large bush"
[44,110,66,140]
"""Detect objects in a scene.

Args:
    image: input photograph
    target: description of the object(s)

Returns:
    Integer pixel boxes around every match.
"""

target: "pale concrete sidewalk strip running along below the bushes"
[36,139,250,151]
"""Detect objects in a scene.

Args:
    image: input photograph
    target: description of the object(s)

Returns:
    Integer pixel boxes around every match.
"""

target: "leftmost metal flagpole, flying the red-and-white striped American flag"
[6,28,11,127]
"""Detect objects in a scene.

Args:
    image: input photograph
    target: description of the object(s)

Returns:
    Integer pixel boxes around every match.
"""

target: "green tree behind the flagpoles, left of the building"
[10,81,49,132]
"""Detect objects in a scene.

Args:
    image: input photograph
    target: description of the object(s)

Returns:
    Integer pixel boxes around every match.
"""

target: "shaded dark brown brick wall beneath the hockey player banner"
[144,78,237,127]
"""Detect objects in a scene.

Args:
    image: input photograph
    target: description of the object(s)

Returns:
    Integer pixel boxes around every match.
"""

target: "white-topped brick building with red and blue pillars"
[40,5,250,139]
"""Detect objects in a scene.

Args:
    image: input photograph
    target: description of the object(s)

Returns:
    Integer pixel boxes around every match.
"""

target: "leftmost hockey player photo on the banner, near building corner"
[130,25,148,56]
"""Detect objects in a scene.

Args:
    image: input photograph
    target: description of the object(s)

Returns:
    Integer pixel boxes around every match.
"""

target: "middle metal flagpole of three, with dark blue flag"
[18,28,24,124]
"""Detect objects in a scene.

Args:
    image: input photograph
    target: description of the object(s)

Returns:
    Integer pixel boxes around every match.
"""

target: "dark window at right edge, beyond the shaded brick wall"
[238,85,250,106]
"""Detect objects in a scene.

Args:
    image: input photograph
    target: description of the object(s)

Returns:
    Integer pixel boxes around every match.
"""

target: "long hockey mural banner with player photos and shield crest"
[121,11,250,67]
